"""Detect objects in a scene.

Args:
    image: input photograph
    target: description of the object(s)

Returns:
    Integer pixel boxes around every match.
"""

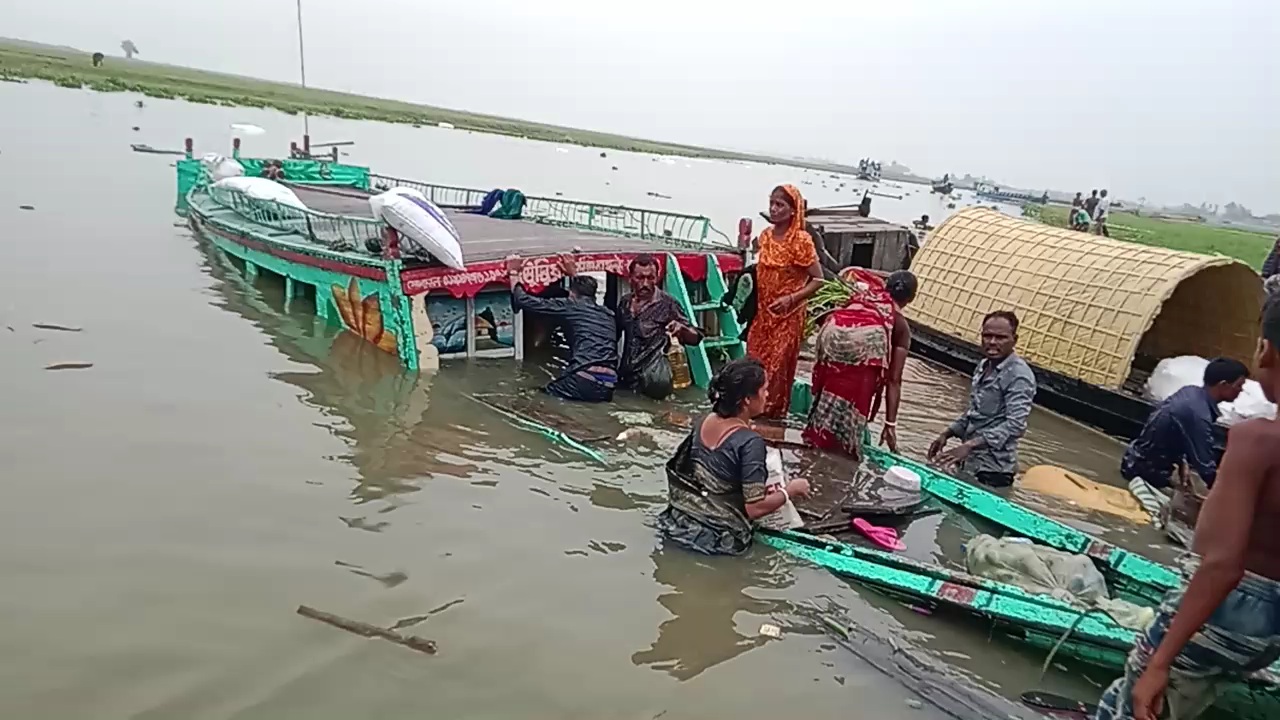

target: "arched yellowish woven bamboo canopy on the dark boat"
[906,208,1265,389]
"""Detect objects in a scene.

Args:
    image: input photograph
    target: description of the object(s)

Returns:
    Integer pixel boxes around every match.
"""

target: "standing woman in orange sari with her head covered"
[746,184,822,418]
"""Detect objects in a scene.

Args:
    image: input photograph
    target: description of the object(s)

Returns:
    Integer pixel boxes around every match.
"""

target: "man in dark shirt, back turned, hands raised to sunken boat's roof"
[507,255,618,402]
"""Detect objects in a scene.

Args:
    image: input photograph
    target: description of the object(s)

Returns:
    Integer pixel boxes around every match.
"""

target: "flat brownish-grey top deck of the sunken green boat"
[292,184,732,266]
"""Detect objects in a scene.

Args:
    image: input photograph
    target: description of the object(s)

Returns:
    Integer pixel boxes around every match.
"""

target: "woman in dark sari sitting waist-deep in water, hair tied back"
[658,357,809,555]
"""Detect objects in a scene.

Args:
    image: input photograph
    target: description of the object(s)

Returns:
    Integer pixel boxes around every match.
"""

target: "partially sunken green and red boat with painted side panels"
[177,140,745,387]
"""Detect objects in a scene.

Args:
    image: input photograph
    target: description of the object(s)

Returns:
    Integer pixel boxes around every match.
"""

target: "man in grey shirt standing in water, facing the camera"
[929,310,1036,487]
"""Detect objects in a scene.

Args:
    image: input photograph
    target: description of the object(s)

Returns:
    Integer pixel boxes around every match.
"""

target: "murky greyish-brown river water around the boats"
[0,83,1177,720]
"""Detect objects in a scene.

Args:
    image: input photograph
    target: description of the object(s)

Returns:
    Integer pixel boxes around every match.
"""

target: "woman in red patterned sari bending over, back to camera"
[804,268,916,459]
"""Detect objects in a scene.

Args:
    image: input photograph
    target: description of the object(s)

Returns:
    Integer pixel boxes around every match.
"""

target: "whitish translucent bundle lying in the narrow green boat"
[964,534,1156,629]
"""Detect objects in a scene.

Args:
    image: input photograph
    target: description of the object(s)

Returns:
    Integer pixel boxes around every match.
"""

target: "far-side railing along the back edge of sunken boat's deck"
[369,173,730,249]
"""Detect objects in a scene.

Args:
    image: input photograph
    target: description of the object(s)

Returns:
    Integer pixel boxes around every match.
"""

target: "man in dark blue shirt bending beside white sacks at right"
[1120,357,1249,525]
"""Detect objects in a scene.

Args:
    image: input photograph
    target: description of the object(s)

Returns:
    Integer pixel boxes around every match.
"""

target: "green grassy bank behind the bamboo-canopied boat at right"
[1023,205,1275,269]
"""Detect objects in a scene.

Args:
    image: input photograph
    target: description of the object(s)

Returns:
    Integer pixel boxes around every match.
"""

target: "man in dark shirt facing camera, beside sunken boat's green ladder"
[617,255,703,400]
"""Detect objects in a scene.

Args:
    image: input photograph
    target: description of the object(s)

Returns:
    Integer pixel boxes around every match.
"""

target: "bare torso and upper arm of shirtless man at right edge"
[1192,419,1280,580]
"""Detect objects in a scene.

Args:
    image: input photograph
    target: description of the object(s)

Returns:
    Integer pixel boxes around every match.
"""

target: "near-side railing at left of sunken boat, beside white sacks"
[209,186,385,252]
